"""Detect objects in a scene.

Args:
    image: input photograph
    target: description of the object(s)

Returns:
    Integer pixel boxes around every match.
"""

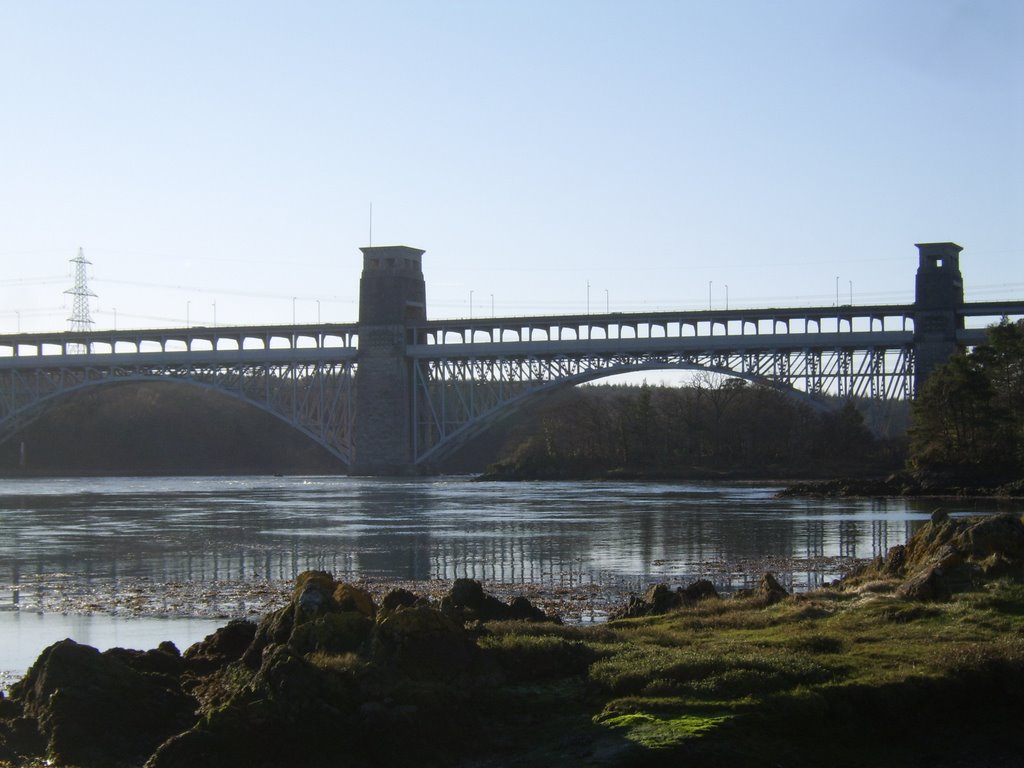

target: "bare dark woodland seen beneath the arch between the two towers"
[488,374,905,478]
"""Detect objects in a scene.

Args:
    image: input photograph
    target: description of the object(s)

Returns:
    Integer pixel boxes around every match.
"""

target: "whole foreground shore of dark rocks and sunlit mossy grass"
[0,514,1024,768]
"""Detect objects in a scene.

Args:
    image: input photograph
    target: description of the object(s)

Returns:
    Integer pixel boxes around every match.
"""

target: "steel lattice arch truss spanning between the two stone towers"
[413,346,913,464]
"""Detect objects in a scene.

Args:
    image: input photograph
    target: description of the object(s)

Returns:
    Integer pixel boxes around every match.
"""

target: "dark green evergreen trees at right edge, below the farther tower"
[909,319,1024,478]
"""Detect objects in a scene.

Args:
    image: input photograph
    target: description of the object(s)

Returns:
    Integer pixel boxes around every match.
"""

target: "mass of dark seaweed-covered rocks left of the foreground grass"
[0,571,577,768]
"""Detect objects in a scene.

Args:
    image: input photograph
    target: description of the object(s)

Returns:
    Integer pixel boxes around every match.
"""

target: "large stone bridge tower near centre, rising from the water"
[352,246,427,475]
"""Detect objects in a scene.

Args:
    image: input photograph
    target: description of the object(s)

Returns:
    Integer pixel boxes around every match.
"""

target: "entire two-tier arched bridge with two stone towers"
[0,243,1024,475]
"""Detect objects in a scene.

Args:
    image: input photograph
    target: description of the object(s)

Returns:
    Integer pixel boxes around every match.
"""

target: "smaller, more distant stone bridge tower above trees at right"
[913,243,964,394]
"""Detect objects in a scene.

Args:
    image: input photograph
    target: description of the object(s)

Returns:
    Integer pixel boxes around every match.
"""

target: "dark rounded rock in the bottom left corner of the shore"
[11,640,197,768]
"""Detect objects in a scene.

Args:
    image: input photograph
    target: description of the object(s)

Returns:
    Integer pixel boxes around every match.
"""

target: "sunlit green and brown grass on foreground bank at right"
[468,582,1024,766]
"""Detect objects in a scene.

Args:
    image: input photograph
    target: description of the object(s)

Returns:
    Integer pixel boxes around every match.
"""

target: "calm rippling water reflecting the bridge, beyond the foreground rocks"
[0,476,1015,688]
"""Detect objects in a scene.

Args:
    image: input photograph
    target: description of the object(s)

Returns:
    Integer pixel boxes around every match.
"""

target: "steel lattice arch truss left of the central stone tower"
[0,360,355,464]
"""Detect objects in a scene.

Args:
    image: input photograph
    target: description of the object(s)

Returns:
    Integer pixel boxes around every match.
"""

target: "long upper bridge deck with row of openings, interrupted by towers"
[0,301,1024,369]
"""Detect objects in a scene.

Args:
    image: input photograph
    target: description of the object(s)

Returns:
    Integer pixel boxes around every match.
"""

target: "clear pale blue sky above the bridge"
[0,0,1024,333]
